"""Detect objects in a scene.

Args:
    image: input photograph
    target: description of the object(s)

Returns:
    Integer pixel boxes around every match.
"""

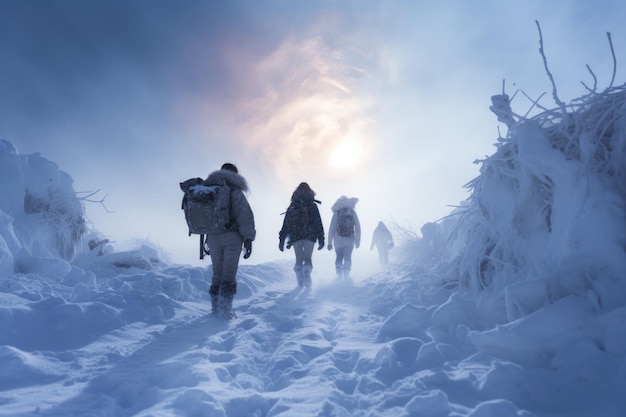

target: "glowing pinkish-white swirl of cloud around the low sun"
[232,36,372,182]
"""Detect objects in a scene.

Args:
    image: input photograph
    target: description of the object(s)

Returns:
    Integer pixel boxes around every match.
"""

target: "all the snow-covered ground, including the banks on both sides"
[0,83,626,417]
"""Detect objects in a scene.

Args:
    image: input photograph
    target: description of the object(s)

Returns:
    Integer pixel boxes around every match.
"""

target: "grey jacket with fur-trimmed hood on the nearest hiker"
[204,169,256,241]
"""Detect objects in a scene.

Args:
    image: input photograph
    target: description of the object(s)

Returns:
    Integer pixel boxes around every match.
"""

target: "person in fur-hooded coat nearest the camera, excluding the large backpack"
[204,163,256,319]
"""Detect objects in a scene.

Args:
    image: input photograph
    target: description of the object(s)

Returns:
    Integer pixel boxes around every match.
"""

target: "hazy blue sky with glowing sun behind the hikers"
[0,0,626,265]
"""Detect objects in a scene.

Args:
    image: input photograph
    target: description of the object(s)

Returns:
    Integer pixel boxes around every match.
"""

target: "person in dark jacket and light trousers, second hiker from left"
[278,182,324,287]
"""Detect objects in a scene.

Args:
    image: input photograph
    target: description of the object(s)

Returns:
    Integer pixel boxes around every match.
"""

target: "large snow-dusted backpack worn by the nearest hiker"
[180,178,232,259]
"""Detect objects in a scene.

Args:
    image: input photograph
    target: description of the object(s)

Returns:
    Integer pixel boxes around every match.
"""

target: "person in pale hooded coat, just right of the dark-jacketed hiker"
[328,195,361,278]
